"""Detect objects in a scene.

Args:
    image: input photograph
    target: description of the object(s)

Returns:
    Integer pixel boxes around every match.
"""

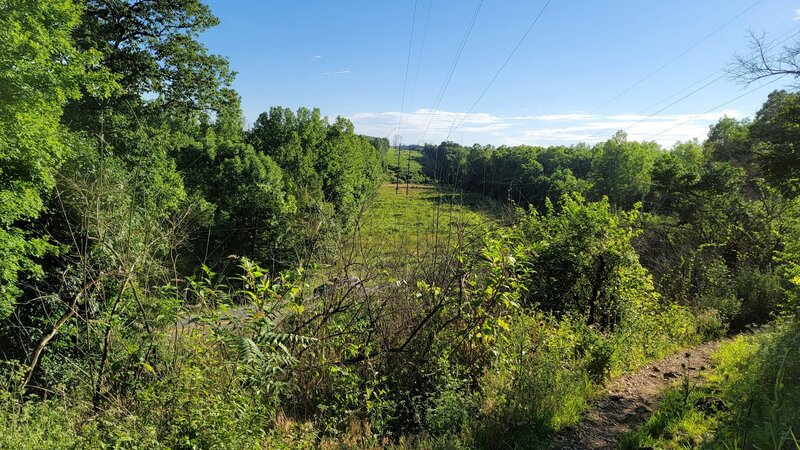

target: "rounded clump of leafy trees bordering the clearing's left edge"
[241,107,381,261]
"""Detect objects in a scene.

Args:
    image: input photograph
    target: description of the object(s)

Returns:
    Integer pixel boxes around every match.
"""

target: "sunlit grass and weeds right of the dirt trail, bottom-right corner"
[621,320,800,449]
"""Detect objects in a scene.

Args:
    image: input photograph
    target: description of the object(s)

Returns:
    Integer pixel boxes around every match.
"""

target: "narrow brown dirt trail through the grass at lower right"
[554,342,719,450]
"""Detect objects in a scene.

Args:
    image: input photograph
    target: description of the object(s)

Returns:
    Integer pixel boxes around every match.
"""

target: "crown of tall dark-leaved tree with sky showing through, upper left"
[68,0,233,126]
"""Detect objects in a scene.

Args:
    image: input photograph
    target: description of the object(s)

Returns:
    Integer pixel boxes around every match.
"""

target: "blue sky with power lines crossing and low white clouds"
[201,0,800,146]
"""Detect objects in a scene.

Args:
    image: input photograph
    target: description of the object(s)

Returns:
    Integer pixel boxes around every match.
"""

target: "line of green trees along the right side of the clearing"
[424,90,800,329]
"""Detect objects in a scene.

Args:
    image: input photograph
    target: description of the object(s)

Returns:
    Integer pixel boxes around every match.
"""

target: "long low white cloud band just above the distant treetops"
[350,109,742,147]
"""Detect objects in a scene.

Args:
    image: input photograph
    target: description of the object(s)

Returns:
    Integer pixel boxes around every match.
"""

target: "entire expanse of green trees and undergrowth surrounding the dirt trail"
[0,0,800,449]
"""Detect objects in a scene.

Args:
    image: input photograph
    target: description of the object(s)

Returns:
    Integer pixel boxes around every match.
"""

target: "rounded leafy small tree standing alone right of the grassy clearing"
[521,194,655,329]
